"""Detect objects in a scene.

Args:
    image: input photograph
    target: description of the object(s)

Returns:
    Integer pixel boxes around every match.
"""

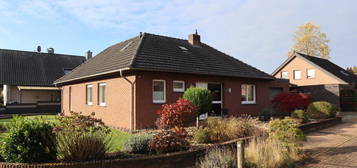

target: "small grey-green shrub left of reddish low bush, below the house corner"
[123,134,152,154]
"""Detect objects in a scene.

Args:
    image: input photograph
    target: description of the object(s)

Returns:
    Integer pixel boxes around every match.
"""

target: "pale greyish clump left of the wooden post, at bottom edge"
[198,147,236,168]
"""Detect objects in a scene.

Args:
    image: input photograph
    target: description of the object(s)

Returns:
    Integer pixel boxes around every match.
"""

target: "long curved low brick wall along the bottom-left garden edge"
[0,137,252,168]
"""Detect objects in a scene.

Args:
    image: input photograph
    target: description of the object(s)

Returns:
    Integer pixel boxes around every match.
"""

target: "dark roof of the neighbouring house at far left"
[0,49,85,86]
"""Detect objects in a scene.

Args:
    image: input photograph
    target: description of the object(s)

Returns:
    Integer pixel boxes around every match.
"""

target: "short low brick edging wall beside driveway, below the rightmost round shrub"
[299,117,342,133]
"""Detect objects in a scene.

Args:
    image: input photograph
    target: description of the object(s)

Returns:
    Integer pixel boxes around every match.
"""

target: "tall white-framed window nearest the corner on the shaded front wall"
[152,80,166,103]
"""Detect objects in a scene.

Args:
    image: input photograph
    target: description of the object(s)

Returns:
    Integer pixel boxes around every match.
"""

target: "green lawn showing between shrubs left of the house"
[0,115,132,152]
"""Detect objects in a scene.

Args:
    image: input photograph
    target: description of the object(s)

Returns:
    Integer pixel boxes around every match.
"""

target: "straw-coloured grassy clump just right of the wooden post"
[245,139,300,168]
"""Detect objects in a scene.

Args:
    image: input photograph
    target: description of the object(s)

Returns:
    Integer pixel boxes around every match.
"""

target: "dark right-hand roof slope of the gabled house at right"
[297,53,357,83]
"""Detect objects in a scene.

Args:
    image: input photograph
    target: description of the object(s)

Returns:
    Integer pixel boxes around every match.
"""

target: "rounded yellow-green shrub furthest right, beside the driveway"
[307,101,337,119]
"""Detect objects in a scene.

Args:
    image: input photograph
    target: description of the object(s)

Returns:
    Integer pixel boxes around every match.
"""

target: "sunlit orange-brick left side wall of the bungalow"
[62,76,136,129]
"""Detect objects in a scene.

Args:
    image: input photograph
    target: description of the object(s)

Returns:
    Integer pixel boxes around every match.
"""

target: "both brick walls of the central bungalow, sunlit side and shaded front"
[62,71,288,129]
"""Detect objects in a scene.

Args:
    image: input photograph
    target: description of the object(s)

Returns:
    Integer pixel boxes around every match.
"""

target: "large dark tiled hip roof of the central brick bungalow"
[55,33,274,84]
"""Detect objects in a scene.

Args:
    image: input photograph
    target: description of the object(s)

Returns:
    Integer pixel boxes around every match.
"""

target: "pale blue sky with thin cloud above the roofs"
[0,0,357,73]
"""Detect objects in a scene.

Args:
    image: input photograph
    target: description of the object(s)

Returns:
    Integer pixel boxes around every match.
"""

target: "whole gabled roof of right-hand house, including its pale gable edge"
[272,52,357,83]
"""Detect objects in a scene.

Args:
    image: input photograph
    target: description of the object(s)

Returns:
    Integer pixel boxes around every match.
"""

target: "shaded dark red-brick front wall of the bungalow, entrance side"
[136,72,289,129]
